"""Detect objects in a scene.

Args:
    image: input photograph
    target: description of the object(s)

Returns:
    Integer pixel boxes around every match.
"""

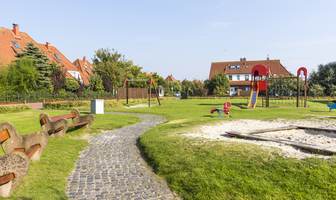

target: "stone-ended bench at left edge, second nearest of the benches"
[0,121,49,161]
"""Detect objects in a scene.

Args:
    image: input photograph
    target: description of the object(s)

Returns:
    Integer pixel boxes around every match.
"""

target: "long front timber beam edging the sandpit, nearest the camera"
[226,131,336,155]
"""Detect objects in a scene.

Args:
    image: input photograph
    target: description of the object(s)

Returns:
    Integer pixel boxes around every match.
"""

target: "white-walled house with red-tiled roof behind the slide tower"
[209,58,289,95]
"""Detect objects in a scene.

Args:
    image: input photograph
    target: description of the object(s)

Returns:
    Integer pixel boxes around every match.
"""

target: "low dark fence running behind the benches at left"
[0,92,116,103]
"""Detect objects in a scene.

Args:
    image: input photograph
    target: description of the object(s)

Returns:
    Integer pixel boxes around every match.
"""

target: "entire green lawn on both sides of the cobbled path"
[0,99,336,199]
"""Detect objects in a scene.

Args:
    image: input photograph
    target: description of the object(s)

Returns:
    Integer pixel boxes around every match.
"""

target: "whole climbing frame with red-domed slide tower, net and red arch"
[247,65,308,109]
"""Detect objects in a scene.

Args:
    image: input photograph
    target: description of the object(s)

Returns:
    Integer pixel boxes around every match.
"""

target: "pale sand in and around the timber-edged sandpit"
[186,119,336,159]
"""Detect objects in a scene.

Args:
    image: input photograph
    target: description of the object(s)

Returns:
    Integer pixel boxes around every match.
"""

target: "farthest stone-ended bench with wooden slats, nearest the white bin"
[40,108,94,137]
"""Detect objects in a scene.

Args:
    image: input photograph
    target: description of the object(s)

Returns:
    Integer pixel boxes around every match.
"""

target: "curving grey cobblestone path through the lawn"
[66,113,179,200]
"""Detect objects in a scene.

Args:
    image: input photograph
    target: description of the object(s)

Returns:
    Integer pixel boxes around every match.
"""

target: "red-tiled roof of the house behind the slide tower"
[209,59,289,79]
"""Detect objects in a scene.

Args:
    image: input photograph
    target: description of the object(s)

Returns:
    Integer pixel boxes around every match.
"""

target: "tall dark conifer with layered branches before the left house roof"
[15,42,52,89]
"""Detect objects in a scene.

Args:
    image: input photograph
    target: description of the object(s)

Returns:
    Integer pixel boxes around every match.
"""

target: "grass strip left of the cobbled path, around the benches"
[0,110,140,199]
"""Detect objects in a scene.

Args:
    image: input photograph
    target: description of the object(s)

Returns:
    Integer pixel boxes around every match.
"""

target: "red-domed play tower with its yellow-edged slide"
[247,65,269,109]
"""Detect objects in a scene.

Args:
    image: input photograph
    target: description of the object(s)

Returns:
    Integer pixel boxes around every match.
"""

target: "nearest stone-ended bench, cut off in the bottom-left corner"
[0,152,29,197]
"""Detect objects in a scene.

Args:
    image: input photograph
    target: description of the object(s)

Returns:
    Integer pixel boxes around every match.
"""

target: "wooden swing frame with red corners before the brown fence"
[122,77,161,107]
